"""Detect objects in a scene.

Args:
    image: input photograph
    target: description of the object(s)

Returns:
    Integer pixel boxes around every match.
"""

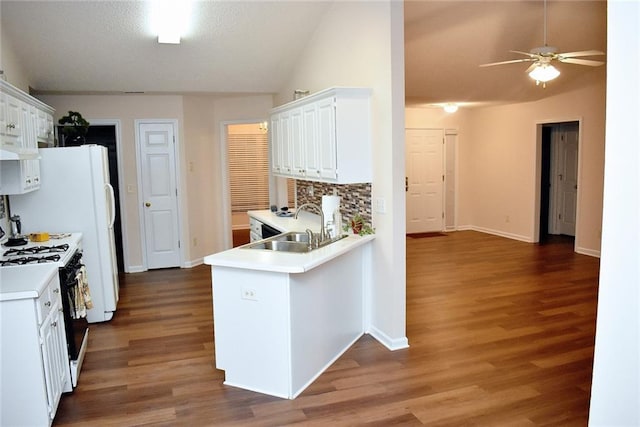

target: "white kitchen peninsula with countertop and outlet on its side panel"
[204,211,374,399]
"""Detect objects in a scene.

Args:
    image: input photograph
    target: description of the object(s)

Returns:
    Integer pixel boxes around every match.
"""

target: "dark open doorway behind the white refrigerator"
[58,119,126,273]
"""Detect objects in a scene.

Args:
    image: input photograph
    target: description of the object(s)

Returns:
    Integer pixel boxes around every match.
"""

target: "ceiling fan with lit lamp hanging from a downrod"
[480,0,604,87]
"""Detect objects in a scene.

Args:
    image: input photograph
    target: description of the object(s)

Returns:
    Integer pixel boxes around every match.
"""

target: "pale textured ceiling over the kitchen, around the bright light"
[2,0,336,93]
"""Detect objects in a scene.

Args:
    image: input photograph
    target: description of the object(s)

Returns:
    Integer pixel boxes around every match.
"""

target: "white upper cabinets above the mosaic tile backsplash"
[270,88,372,184]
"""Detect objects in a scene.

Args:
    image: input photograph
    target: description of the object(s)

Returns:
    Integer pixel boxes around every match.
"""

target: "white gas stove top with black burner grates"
[0,233,82,267]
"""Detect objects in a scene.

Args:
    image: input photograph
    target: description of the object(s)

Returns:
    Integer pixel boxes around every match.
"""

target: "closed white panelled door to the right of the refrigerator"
[138,123,180,269]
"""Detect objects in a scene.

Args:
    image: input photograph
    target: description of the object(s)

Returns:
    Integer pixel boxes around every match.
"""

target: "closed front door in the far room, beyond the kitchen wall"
[405,129,444,233]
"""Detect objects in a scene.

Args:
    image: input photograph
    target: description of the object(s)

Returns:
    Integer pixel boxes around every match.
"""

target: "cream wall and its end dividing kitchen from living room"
[276,1,407,348]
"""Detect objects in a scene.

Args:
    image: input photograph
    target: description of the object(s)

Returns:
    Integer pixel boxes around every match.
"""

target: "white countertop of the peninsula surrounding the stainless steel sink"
[204,210,375,273]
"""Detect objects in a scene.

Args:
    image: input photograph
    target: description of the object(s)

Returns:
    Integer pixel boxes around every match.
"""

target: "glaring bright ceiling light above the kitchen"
[153,0,192,44]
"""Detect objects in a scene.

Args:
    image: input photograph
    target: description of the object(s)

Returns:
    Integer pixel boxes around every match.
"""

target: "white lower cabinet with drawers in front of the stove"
[0,267,71,426]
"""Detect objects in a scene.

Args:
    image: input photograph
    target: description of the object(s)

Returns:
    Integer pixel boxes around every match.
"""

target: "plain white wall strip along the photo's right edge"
[589,1,640,426]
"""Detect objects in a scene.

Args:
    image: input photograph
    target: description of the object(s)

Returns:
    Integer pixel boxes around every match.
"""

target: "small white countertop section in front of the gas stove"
[0,262,58,301]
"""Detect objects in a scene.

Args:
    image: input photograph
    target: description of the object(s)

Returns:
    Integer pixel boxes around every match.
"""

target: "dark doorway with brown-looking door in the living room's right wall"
[538,121,580,244]
